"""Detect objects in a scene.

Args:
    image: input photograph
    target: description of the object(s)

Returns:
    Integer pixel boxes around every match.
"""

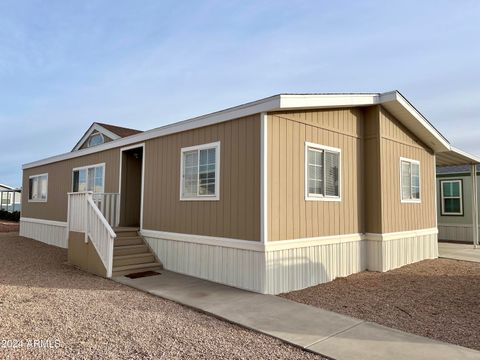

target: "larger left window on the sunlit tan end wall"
[305,142,341,201]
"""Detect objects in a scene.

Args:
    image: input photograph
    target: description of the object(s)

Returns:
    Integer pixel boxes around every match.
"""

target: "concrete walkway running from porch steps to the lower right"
[113,270,480,360]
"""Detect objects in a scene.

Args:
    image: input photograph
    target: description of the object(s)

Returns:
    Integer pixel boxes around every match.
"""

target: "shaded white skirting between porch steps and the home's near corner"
[144,235,265,293]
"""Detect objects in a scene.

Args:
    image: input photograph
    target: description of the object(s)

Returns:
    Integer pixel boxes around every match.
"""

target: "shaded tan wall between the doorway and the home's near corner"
[143,114,260,241]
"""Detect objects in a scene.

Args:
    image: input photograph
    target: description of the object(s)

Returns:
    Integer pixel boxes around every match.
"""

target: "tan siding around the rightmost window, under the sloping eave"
[380,107,436,233]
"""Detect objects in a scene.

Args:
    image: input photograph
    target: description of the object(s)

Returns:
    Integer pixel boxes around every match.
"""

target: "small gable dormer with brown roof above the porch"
[72,122,142,151]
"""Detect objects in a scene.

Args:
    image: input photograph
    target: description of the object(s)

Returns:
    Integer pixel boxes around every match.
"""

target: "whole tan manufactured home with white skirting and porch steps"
[20,91,477,294]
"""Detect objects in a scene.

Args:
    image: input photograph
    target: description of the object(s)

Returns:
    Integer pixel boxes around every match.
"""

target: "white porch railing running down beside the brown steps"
[68,192,117,277]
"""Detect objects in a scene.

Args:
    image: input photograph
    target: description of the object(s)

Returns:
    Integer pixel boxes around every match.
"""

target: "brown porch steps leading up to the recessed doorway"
[112,228,163,276]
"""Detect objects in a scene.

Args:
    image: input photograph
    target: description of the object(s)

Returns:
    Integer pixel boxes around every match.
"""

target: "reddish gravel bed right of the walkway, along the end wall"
[280,259,480,350]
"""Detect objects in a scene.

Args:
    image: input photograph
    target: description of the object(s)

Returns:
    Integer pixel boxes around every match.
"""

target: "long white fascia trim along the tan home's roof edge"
[22,91,458,169]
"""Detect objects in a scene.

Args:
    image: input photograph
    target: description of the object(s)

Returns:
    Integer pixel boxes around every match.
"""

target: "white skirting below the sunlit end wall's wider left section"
[265,238,367,294]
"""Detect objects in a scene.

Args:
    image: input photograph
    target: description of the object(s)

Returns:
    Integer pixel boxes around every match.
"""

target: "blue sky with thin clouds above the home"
[0,0,480,186]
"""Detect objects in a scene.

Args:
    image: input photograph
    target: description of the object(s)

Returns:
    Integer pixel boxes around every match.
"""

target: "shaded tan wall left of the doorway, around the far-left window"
[22,148,120,221]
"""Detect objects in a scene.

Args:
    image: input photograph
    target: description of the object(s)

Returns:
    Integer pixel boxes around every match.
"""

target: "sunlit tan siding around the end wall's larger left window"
[268,108,363,241]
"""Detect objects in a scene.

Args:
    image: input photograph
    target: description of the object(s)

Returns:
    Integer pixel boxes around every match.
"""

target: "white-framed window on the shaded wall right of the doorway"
[180,142,220,200]
